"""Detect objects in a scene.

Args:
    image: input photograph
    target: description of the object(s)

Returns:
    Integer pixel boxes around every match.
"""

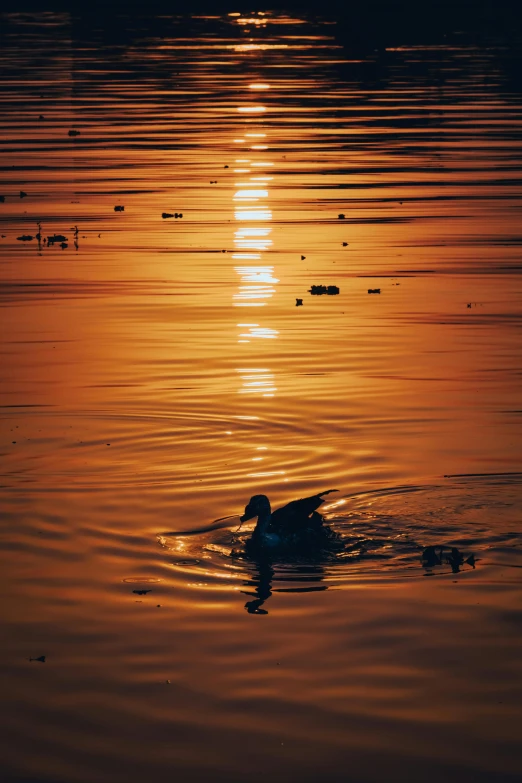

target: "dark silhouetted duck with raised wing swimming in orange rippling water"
[239,489,338,550]
